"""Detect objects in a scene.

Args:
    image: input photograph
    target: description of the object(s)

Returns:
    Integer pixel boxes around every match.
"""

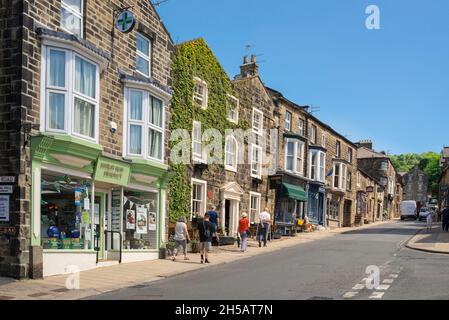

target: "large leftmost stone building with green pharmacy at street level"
[0,0,173,278]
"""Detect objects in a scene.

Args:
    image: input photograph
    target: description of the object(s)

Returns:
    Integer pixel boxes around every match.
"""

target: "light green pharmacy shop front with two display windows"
[31,134,169,276]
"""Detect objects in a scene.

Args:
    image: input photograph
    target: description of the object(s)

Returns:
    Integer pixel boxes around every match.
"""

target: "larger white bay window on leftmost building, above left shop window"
[43,47,99,142]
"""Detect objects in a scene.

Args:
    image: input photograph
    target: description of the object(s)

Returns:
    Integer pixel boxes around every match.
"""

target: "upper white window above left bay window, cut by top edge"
[61,0,83,38]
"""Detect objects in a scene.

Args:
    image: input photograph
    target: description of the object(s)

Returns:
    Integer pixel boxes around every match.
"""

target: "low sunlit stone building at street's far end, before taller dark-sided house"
[355,168,385,225]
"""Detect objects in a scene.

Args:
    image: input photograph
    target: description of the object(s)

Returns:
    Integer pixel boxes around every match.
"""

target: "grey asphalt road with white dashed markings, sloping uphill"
[89,221,449,300]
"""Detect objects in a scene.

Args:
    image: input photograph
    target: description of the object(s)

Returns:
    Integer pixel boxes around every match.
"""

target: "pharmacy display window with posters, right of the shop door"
[123,189,158,250]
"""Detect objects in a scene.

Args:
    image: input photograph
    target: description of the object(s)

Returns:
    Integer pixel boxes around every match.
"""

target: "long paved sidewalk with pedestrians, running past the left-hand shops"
[0,221,391,300]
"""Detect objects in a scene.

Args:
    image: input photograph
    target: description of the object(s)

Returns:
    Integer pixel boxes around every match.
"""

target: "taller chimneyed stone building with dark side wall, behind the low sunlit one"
[357,140,398,219]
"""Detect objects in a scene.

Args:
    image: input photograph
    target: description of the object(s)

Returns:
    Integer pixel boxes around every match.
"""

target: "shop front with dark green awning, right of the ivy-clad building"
[270,173,308,236]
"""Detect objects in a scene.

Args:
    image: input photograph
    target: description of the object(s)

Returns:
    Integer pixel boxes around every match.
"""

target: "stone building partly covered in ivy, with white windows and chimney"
[170,39,275,237]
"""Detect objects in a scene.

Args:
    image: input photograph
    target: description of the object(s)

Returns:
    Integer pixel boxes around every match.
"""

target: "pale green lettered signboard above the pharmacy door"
[94,157,131,186]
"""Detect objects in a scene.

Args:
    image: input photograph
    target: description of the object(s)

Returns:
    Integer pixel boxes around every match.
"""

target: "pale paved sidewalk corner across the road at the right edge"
[406,224,449,254]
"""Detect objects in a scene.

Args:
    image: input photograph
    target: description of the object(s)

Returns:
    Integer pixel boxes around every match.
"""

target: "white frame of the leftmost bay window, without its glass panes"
[41,44,100,143]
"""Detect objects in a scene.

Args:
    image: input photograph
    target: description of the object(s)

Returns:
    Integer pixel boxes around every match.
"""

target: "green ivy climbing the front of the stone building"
[169,39,249,222]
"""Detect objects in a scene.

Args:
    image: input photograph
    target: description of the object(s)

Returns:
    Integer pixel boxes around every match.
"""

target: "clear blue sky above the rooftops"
[153,0,449,154]
